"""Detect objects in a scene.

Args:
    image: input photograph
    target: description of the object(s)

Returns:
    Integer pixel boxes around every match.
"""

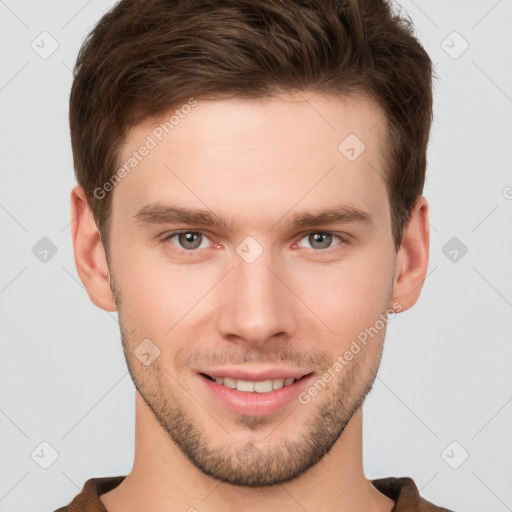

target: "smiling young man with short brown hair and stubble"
[59,0,456,512]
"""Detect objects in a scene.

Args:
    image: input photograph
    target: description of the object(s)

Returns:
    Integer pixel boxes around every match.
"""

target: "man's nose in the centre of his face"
[218,247,297,347]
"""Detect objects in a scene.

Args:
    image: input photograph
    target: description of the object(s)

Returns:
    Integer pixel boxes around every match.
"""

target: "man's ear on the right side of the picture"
[390,196,430,312]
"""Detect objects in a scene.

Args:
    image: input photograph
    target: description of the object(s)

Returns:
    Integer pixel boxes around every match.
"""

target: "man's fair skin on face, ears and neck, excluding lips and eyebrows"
[71,91,429,512]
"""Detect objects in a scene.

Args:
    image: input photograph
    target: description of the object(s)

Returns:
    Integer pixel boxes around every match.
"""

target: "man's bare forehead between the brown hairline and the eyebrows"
[114,92,387,232]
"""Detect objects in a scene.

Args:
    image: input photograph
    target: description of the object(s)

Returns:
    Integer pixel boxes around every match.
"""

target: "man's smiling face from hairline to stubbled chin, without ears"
[109,93,396,487]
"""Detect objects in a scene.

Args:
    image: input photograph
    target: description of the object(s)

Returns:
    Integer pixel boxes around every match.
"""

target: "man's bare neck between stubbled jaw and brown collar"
[101,393,394,512]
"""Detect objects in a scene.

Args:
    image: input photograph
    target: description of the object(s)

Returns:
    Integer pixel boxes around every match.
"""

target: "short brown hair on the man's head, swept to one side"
[69,0,432,257]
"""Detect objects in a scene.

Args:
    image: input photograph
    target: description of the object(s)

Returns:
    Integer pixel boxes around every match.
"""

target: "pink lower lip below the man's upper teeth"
[199,373,313,416]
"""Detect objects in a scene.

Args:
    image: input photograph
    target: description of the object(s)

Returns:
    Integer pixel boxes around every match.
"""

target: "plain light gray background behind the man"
[0,0,512,512]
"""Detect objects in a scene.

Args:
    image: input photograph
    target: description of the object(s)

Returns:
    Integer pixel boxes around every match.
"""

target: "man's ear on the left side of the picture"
[71,185,117,311]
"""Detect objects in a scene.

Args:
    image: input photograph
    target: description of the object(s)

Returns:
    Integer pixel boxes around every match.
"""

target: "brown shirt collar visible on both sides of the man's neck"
[54,476,453,512]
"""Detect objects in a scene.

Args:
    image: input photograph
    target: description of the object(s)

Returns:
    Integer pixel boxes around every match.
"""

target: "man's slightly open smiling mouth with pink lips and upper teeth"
[196,372,314,416]
